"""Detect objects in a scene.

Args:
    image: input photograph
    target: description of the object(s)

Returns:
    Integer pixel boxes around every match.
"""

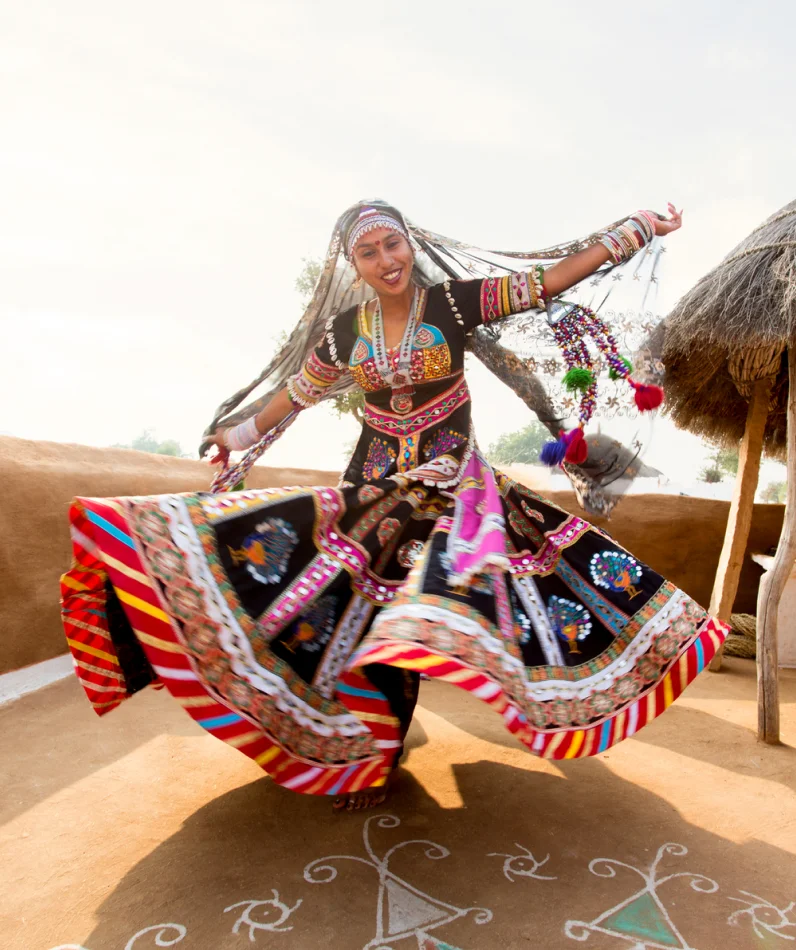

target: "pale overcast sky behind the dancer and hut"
[0,0,796,490]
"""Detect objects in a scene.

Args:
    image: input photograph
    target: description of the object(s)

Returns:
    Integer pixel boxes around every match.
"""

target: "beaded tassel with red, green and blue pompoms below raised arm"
[540,306,663,468]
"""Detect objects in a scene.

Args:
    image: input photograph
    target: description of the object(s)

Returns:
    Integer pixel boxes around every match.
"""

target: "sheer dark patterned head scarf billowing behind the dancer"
[200,199,661,515]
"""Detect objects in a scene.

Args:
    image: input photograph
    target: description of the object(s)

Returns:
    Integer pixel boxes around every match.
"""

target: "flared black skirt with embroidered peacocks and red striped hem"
[62,453,726,795]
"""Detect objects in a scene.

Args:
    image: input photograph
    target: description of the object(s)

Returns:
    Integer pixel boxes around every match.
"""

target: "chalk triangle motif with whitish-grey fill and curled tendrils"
[304,815,492,950]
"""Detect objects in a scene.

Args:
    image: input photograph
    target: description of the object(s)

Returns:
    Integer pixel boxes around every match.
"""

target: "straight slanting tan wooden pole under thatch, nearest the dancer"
[709,376,774,673]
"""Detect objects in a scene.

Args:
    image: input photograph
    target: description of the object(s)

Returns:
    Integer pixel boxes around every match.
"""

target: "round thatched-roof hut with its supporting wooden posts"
[645,201,796,742]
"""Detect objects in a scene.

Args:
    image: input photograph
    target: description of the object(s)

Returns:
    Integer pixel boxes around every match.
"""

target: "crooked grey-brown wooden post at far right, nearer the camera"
[757,343,796,745]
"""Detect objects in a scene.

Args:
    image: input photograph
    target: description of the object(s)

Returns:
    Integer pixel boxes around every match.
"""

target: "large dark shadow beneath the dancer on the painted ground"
[57,712,796,950]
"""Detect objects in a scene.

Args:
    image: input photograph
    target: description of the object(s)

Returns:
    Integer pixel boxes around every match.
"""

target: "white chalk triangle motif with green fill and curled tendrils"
[564,843,719,950]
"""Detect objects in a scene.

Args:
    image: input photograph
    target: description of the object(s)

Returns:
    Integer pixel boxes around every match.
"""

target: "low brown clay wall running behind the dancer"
[0,437,783,673]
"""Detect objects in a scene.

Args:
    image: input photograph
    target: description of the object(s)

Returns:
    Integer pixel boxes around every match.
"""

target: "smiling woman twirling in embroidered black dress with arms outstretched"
[62,202,725,810]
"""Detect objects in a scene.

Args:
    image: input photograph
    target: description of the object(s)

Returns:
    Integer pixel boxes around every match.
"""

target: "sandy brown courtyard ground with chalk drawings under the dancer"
[0,660,796,950]
